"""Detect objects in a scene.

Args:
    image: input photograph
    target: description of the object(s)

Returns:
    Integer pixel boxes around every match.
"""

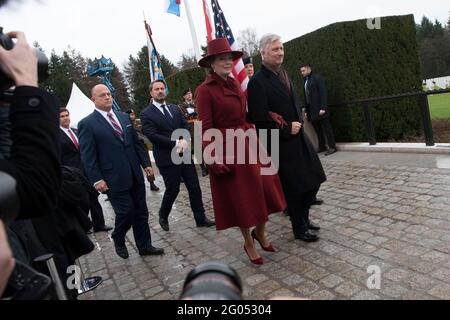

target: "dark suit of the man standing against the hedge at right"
[303,73,336,150]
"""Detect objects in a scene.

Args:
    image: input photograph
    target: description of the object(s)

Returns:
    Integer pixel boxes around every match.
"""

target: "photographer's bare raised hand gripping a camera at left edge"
[0,32,38,87]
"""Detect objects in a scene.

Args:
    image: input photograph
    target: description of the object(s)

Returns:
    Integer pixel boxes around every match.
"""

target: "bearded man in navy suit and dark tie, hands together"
[141,80,215,231]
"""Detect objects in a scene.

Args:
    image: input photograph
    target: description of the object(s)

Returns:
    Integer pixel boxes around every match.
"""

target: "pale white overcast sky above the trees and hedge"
[0,0,450,66]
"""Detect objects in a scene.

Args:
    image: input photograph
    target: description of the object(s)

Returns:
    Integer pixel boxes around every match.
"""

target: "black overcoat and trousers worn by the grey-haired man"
[248,65,326,234]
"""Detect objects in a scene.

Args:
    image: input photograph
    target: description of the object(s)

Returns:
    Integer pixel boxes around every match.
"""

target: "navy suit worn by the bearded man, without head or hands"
[141,105,206,224]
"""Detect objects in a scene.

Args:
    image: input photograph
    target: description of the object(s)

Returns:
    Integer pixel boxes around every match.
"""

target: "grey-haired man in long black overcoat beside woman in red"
[248,35,326,242]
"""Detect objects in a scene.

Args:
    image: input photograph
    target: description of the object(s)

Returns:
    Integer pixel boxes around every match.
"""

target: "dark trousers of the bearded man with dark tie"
[159,164,206,223]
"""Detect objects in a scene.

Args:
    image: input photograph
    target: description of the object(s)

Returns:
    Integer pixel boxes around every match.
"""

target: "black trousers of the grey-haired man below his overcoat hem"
[285,187,320,235]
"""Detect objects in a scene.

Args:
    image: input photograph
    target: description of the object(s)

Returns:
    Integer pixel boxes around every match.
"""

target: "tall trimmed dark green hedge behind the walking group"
[168,15,422,142]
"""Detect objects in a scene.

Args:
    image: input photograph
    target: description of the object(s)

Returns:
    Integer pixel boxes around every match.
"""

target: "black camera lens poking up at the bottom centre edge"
[180,261,243,300]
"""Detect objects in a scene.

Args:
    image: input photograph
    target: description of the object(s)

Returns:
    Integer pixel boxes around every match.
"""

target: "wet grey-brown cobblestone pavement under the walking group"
[80,153,450,300]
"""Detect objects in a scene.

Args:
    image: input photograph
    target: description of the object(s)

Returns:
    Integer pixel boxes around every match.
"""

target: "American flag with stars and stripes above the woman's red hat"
[203,0,249,93]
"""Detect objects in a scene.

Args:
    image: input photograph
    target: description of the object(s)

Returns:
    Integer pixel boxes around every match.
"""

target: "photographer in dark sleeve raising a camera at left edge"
[0,32,61,219]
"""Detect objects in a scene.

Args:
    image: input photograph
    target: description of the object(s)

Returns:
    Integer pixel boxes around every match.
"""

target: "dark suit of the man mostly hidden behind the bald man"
[59,129,105,230]
